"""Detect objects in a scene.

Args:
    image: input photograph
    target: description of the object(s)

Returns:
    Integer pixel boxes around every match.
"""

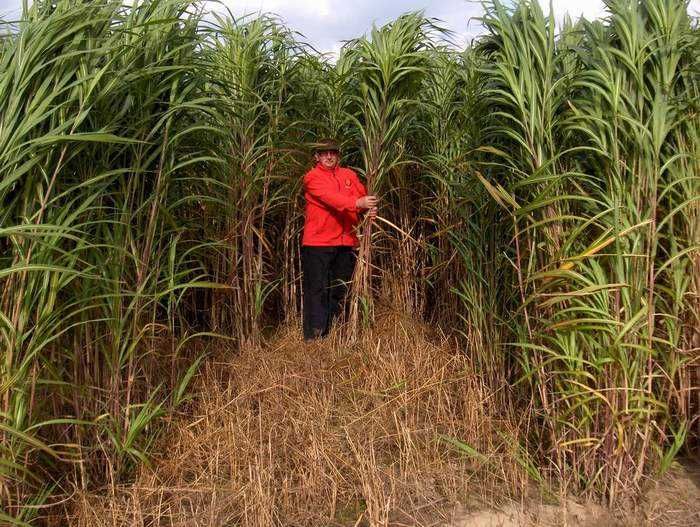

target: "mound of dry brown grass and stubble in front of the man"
[64,313,525,527]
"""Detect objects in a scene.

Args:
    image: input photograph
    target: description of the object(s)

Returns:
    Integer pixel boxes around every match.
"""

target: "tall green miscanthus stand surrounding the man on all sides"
[0,0,700,525]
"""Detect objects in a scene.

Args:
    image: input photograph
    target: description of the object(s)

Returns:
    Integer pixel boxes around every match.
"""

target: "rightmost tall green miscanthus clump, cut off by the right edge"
[554,0,700,501]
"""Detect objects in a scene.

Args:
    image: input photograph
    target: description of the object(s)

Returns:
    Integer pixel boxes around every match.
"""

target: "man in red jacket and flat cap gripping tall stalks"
[301,139,377,340]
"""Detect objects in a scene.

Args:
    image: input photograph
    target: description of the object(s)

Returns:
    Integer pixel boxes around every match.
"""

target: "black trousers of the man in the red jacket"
[301,246,356,340]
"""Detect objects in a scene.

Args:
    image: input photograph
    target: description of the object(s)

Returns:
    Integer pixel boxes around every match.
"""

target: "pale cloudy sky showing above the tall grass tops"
[0,0,700,52]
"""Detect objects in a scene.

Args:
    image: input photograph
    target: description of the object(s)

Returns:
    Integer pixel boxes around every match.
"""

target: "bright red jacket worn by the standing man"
[302,163,367,247]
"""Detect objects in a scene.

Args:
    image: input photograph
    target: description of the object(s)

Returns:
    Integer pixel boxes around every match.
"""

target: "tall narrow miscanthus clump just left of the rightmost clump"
[478,1,586,462]
